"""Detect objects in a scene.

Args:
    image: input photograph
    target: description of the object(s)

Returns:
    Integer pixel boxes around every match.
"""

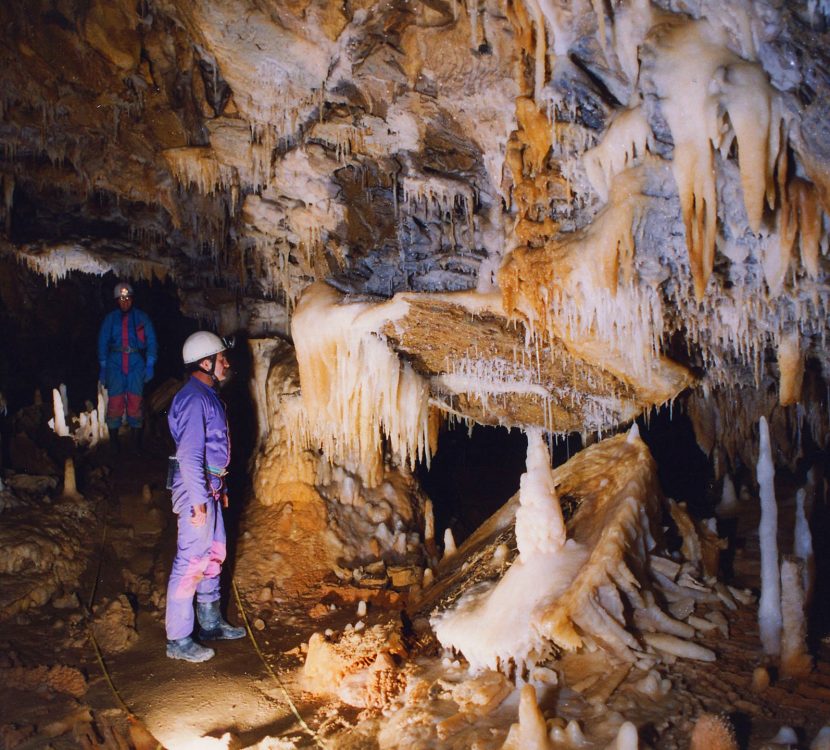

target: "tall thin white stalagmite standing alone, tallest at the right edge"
[757,417,781,656]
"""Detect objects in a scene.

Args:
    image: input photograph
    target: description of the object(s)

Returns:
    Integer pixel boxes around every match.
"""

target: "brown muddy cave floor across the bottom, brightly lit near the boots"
[0,446,830,750]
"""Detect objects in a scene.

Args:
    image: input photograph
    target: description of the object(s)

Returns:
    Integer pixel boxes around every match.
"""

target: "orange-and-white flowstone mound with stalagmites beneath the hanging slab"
[304,430,751,750]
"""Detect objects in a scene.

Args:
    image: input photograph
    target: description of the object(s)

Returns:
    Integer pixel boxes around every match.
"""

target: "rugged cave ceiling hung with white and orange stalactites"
[0,0,830,438]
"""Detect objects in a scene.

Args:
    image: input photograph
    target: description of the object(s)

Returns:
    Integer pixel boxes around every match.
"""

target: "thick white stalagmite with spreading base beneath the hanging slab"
[431,429,587,672]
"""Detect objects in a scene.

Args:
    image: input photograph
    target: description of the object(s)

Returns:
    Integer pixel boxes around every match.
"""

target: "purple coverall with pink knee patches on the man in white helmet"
[165,377,231,641]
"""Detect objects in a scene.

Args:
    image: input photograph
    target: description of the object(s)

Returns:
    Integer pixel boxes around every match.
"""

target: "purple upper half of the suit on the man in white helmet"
[167,376,231,513]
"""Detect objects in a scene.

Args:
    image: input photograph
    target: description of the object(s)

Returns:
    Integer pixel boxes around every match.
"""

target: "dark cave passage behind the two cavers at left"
[0,259,256,502]
